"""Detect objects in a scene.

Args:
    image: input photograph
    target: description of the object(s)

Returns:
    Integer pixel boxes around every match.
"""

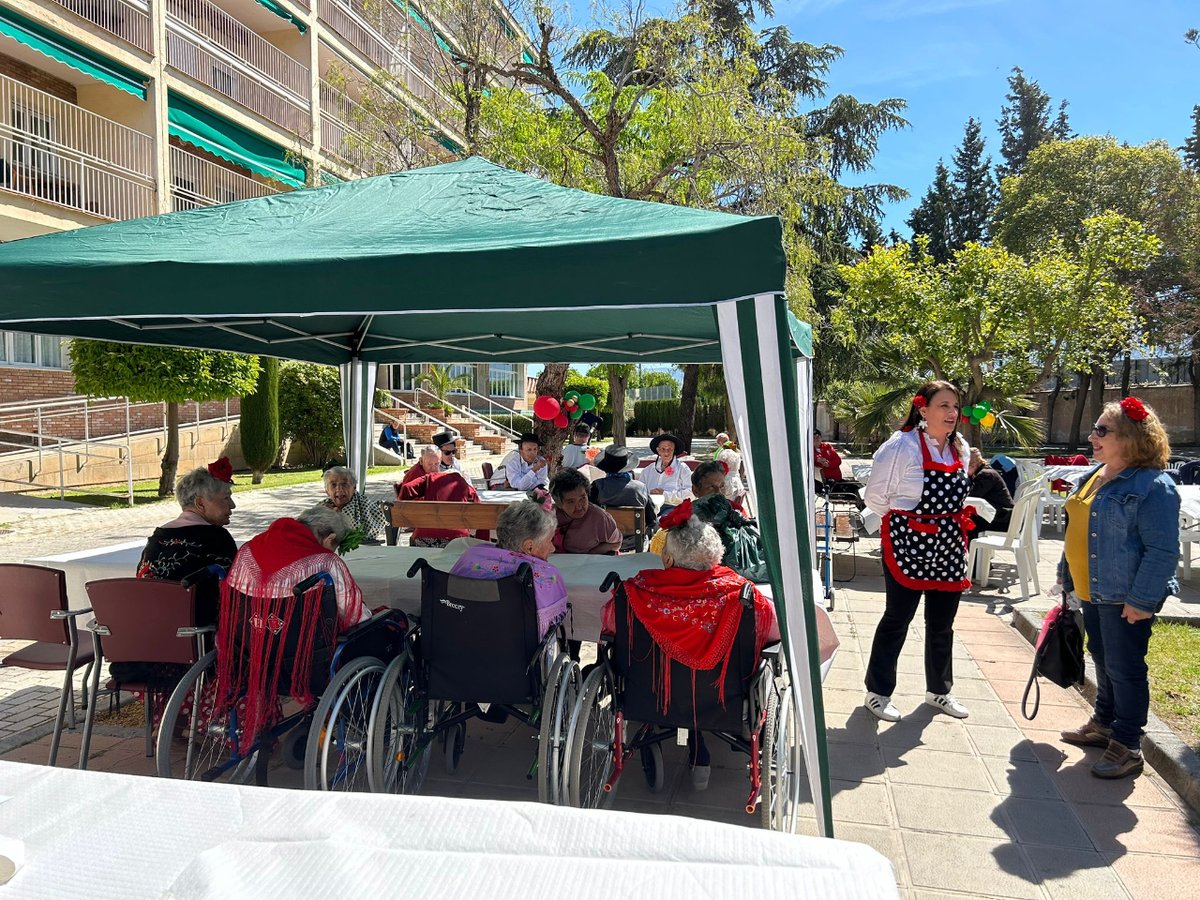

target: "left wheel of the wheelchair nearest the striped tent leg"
[565,666,617,809]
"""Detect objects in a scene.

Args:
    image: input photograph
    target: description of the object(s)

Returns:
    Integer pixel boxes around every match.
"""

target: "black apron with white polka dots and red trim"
[881,431,974,590]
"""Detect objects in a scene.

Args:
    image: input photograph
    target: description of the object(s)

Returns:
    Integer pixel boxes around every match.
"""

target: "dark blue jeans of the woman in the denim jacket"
[1084,602,1154,750]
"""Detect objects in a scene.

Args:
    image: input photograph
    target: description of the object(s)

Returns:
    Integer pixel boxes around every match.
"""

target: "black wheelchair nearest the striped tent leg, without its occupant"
[563,572,800,832]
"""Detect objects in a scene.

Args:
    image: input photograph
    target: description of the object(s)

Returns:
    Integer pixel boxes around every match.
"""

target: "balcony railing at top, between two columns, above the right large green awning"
[167,0,312,134]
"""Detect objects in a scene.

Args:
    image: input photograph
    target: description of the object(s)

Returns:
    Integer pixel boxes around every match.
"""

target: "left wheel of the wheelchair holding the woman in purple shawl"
[367,648,431,793]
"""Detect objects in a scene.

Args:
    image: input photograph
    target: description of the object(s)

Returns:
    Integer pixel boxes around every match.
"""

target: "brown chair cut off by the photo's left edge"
[0,563,95,766]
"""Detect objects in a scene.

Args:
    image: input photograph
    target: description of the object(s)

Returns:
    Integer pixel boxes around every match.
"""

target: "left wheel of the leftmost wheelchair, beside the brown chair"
[155,650,258,784]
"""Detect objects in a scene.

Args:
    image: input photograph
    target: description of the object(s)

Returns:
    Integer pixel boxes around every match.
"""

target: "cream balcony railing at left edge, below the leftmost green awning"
[0,76,155,220]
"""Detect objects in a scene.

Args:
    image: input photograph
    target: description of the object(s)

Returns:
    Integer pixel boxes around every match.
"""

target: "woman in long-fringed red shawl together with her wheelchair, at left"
[156,505,407,790]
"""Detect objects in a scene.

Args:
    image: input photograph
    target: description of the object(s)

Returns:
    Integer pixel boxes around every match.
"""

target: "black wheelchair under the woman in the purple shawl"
[367,559,580,804]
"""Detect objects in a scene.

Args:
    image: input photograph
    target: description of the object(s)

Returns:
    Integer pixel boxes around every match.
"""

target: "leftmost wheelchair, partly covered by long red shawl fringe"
[155,572,408,791]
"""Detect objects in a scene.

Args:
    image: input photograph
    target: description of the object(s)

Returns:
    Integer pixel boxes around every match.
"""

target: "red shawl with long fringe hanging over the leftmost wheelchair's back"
[216,518,364,751]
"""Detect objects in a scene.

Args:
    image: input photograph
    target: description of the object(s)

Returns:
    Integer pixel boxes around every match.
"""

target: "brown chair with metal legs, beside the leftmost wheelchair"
[79,578,216,769]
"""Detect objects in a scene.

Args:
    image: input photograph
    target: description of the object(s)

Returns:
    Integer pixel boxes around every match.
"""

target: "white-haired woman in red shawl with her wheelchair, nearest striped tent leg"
[564,516,794,827]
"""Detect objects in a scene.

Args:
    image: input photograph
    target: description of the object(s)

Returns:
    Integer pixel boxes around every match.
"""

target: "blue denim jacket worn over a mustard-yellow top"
[1058,467,1180,612]
